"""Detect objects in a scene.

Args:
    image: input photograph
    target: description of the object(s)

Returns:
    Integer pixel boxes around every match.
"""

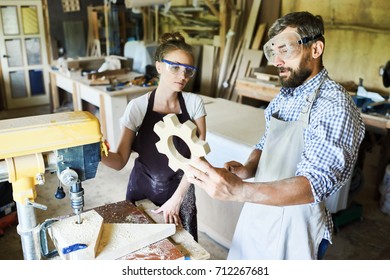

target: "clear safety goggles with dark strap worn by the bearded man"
[263,32,322,63]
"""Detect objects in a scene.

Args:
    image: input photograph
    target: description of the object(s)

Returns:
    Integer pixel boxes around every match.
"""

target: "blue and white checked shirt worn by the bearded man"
[255,68,365,242]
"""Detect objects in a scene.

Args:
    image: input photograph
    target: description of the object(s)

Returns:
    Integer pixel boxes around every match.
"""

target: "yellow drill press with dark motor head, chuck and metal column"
[0,111,102,260]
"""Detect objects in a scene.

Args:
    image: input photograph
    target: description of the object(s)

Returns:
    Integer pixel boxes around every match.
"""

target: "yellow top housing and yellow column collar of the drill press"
[0,111,102,204]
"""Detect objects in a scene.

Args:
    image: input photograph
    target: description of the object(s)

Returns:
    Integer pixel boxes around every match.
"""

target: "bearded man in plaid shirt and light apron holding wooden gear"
[185,12,365,259]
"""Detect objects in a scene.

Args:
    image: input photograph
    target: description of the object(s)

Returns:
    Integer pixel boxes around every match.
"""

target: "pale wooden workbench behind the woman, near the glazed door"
[50,70,156,150]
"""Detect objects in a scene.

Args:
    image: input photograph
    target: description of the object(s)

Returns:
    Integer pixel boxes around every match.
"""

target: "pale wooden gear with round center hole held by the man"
[153,114,210,172]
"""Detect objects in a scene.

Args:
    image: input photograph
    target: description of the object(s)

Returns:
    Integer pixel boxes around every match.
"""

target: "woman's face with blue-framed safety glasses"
[156,50,194,92]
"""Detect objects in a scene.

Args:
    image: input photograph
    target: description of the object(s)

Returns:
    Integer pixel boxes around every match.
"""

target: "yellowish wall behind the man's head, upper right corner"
[282,0,390,96]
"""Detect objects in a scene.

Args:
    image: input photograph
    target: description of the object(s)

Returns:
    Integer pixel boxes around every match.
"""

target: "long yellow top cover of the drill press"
[0,111,102,159]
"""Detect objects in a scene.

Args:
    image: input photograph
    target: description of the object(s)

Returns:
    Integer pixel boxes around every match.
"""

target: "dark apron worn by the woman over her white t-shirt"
[126,90,198,241]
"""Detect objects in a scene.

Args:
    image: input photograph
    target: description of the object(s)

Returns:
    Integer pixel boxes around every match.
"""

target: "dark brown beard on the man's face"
[279,54,312,88]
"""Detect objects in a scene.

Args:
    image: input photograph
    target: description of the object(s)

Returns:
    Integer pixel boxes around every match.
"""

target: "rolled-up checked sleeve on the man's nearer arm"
[296,100,364,203]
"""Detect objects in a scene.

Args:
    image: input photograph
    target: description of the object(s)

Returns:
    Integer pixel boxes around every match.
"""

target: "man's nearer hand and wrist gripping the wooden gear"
[184,158,244,201]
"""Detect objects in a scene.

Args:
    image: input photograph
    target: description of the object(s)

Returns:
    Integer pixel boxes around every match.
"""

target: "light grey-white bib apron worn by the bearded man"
[228,83,326,260]
